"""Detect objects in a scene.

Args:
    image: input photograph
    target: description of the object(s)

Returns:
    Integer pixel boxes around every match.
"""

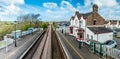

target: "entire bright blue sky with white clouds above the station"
[0,0,120,21]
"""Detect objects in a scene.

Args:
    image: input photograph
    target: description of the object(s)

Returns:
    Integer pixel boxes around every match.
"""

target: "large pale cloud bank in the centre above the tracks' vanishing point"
[41,1,76,21]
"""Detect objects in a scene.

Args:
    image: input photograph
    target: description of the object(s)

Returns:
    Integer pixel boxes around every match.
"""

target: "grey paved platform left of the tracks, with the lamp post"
[0,31,41,59]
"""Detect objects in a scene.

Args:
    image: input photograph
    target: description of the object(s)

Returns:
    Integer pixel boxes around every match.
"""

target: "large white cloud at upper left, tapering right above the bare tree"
[0,0,40,21]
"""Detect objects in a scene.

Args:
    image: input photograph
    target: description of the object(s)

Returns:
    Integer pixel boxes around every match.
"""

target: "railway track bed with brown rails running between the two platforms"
[20,25,69,59]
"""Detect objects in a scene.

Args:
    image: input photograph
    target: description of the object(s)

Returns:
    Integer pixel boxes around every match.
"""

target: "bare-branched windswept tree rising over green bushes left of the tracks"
[17,13,40,30]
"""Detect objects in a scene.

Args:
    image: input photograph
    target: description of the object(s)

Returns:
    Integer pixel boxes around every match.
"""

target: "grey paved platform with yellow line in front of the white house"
[59,33,100,59]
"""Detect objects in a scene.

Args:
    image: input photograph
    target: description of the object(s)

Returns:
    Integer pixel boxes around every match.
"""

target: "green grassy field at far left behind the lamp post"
[0,21,39,40]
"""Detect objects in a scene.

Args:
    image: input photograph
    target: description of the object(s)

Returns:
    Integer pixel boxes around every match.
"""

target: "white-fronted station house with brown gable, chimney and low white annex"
[69,4,113,43]
